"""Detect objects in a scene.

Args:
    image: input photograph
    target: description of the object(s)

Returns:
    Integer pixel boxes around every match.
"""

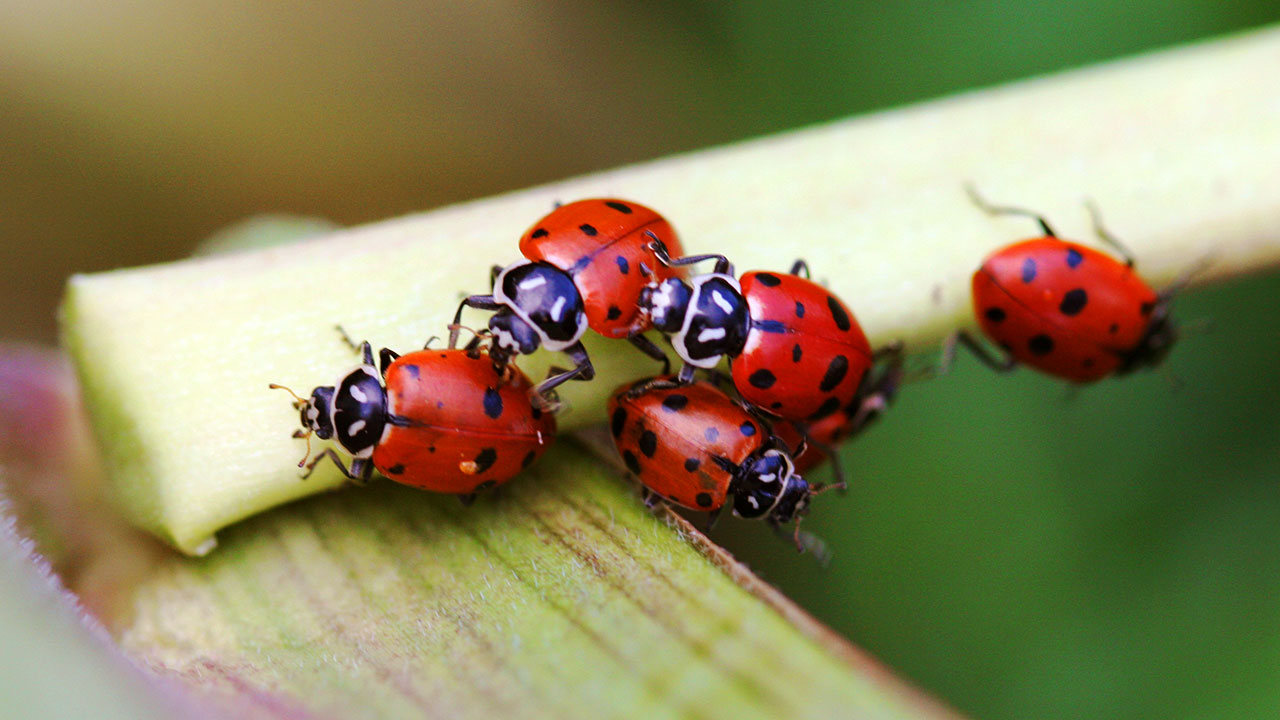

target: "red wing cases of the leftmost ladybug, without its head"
[372,350,556,495]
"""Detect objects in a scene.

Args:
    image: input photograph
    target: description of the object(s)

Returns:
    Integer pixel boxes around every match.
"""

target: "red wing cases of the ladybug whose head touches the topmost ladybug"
[730,270,873,421]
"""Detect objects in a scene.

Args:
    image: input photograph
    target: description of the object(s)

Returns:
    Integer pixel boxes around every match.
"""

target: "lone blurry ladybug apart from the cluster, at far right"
[945,188,1178,383]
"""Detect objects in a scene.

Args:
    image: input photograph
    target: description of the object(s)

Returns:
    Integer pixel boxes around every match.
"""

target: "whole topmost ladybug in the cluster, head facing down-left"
[451,199,684,396]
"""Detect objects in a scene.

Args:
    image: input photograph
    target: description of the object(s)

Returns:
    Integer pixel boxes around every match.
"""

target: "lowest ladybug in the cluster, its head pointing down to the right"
[608,377,822,537]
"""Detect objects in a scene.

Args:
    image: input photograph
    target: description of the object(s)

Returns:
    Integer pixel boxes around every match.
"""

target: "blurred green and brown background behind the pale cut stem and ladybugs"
[0,0,1280,719]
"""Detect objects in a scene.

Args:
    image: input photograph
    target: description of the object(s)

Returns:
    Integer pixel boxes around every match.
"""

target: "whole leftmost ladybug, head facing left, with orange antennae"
[271,342,556,503]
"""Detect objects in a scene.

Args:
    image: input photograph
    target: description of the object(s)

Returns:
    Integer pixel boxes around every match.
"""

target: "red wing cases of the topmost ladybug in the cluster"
[520,197,685,338]
